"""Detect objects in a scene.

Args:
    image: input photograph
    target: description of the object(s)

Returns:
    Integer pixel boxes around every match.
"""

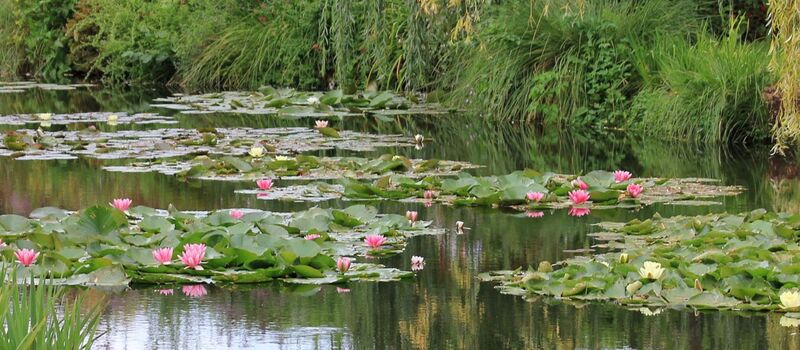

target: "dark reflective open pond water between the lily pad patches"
[0,88,800,349]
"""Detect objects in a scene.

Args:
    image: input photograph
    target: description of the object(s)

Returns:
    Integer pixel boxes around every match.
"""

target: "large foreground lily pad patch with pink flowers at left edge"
[0,204,443,286]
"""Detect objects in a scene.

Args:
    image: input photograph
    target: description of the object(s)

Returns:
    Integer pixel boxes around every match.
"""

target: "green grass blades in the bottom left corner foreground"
[0,268,103,350]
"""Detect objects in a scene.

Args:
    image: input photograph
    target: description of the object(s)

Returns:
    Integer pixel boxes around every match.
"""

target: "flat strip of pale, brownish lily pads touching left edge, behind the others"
[0,127,415,160]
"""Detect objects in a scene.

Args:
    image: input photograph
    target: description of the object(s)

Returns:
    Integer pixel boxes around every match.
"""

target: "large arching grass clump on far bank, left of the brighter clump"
[453,0,699,126]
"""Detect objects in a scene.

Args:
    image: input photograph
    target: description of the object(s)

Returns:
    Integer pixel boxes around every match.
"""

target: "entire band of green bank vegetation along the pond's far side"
[0,0,796,143]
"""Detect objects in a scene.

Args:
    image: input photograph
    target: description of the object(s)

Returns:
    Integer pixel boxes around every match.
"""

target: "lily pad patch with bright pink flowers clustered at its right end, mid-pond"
[290,170,743,211]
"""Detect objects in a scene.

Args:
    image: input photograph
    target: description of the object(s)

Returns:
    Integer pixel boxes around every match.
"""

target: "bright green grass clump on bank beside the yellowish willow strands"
[630,24,775,143]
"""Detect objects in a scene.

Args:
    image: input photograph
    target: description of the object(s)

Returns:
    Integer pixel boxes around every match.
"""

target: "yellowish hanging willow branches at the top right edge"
[769,0,800,154]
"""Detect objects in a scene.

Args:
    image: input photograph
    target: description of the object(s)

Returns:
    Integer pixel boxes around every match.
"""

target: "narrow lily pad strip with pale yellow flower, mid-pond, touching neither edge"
[104,154,477,181]
